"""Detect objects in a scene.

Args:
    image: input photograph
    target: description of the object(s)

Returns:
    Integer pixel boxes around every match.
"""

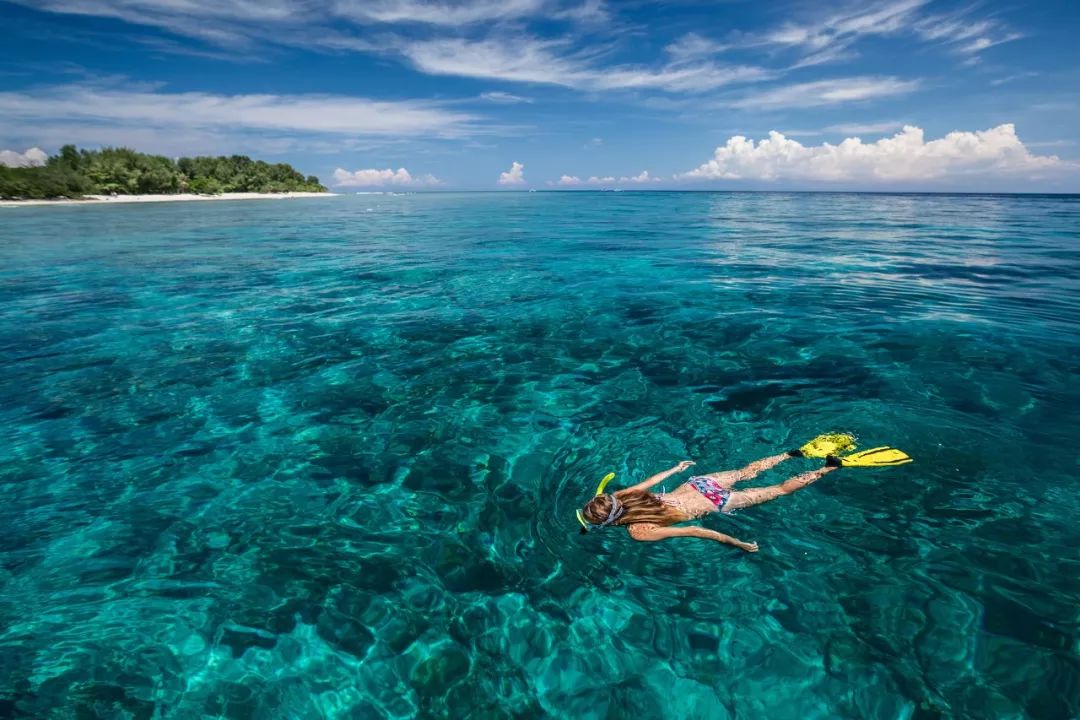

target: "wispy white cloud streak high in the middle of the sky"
[400,36,774,92]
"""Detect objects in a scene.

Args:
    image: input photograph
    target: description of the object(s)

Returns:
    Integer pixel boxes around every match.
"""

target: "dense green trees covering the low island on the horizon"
[0,145,326,200]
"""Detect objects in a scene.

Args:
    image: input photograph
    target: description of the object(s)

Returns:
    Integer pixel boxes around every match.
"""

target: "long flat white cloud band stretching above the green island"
[0,85,478,137]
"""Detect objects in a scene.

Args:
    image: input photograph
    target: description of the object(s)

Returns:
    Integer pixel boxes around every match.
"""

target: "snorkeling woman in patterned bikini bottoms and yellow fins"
[578,434,912,553]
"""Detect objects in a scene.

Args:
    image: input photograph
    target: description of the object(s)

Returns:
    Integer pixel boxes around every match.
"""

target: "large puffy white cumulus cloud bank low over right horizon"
[678,124,1059,182]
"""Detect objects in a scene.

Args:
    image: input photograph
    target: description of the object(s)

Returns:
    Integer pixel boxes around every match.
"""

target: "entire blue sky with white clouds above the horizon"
[0,0,1080,192]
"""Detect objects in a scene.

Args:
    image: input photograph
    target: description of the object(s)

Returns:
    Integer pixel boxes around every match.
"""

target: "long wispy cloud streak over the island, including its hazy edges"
[0,82,486,155]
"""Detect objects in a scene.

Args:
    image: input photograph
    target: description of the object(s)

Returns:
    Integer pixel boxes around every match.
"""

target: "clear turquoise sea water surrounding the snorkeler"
[0,193,1080,720]
